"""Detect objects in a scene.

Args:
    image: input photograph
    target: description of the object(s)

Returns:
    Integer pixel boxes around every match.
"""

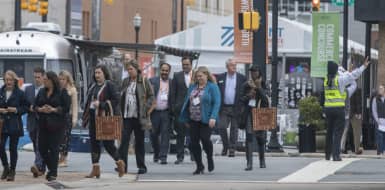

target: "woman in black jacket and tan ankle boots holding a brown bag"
[83,65,125,178]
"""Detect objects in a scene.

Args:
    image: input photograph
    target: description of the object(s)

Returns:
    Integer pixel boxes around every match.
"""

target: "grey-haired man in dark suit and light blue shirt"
[217,59,246,157]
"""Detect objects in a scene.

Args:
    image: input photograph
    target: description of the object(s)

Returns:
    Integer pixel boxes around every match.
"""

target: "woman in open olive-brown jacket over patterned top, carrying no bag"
[119,60,154,174]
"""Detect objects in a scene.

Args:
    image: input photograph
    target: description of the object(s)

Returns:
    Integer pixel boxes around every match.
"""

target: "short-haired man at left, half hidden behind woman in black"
[25,67,45,177]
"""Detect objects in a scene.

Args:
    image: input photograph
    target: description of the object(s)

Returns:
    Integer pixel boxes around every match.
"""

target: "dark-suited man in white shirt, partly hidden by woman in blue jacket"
[170,57,193,164]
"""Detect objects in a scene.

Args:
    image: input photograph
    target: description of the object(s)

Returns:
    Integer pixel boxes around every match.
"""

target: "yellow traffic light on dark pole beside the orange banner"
[238,11,261,31]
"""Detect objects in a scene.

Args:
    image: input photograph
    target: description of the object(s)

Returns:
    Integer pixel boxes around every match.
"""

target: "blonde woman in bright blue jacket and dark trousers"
[179,66,221,175]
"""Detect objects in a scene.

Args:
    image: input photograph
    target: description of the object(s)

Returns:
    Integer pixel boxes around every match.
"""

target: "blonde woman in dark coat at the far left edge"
[0,70,29,181]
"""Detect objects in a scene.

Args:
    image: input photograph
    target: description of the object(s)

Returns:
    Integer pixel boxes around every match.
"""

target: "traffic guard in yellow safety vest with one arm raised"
[324,59,369,161]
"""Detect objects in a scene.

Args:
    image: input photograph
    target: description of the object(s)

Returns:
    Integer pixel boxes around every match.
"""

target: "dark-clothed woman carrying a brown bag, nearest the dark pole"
[239,65,269,171]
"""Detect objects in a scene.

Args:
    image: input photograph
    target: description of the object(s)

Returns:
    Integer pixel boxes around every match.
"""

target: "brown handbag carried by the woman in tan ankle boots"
[95,101,123,140]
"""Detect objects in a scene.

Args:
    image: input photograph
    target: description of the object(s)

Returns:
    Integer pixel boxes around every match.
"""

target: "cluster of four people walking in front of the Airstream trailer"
[0,68,78,181]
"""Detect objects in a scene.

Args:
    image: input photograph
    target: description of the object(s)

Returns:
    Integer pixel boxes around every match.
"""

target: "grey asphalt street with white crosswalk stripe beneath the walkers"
[0,152,385,190]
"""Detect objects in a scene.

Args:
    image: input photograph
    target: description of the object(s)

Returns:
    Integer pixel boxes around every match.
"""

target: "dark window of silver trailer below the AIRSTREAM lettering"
[0,59,43,83]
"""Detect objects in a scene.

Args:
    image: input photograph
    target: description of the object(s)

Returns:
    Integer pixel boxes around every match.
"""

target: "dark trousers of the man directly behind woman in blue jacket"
[174,115,192,160]
